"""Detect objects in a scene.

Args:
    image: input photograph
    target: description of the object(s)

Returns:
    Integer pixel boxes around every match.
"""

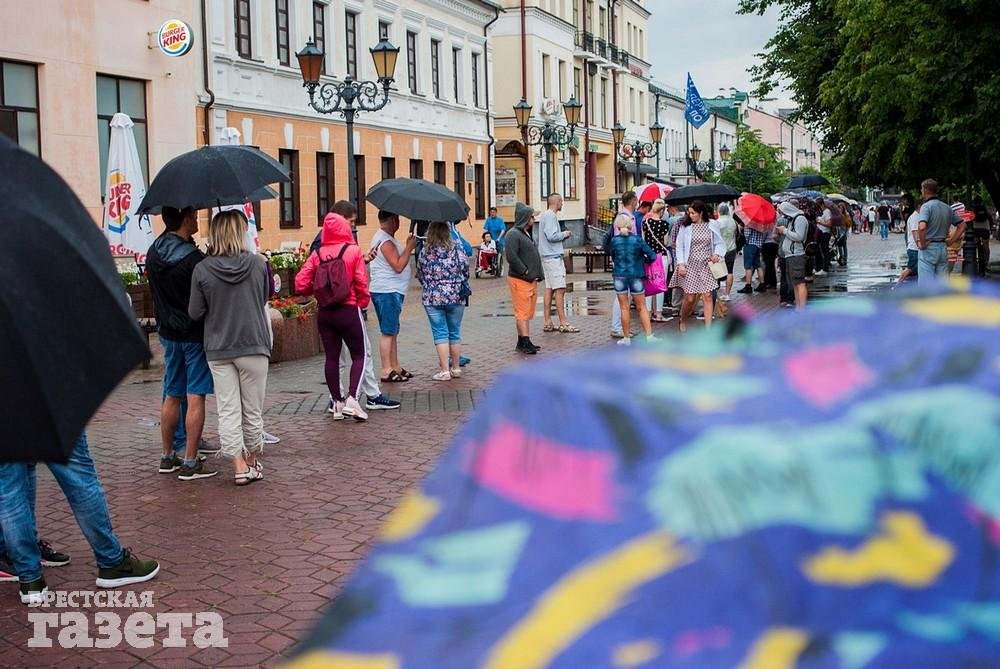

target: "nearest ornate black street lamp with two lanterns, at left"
[295,39,399,204]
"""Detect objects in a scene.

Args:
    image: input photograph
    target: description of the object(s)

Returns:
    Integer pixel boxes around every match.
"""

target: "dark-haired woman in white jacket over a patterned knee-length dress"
[677,200,726,332]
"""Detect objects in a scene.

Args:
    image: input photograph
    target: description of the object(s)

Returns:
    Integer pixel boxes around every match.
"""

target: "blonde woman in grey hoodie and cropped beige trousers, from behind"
[188,210,271,486]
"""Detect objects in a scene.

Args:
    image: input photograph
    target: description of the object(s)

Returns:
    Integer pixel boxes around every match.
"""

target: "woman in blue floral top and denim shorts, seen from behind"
[417,223,469,381]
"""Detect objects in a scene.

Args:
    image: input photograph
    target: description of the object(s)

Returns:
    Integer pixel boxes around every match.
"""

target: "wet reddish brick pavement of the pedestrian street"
[0,235,984,669]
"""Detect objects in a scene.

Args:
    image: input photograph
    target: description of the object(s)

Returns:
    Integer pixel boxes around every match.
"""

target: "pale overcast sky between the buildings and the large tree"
[646,0,791,109]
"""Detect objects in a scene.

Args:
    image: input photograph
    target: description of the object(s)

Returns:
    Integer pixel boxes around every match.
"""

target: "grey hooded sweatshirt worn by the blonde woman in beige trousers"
[188,252,271,360]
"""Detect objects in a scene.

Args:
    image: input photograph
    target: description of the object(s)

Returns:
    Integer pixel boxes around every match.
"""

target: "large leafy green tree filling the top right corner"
[741,0,1000,204]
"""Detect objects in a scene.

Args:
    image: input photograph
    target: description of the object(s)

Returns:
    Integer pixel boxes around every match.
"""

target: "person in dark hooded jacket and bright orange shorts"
[504,202,544,355]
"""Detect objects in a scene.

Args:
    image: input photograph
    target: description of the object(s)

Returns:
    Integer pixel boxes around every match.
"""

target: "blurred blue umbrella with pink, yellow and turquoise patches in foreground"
[291,286,1000,669]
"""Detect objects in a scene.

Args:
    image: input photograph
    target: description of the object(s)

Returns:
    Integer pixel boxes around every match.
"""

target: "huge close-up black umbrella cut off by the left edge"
[0,136,149,462]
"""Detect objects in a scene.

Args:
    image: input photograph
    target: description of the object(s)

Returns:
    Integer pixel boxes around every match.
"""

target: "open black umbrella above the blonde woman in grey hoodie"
[139,146,291,214]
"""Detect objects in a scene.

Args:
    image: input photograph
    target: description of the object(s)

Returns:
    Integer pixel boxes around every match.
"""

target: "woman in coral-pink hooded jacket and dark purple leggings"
[295,211,371,421]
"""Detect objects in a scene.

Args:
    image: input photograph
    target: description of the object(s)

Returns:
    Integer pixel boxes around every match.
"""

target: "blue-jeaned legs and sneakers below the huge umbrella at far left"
[0,434,160,606]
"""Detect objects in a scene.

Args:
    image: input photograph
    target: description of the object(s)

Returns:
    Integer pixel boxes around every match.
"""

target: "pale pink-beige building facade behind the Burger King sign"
[0,0,201,221]
